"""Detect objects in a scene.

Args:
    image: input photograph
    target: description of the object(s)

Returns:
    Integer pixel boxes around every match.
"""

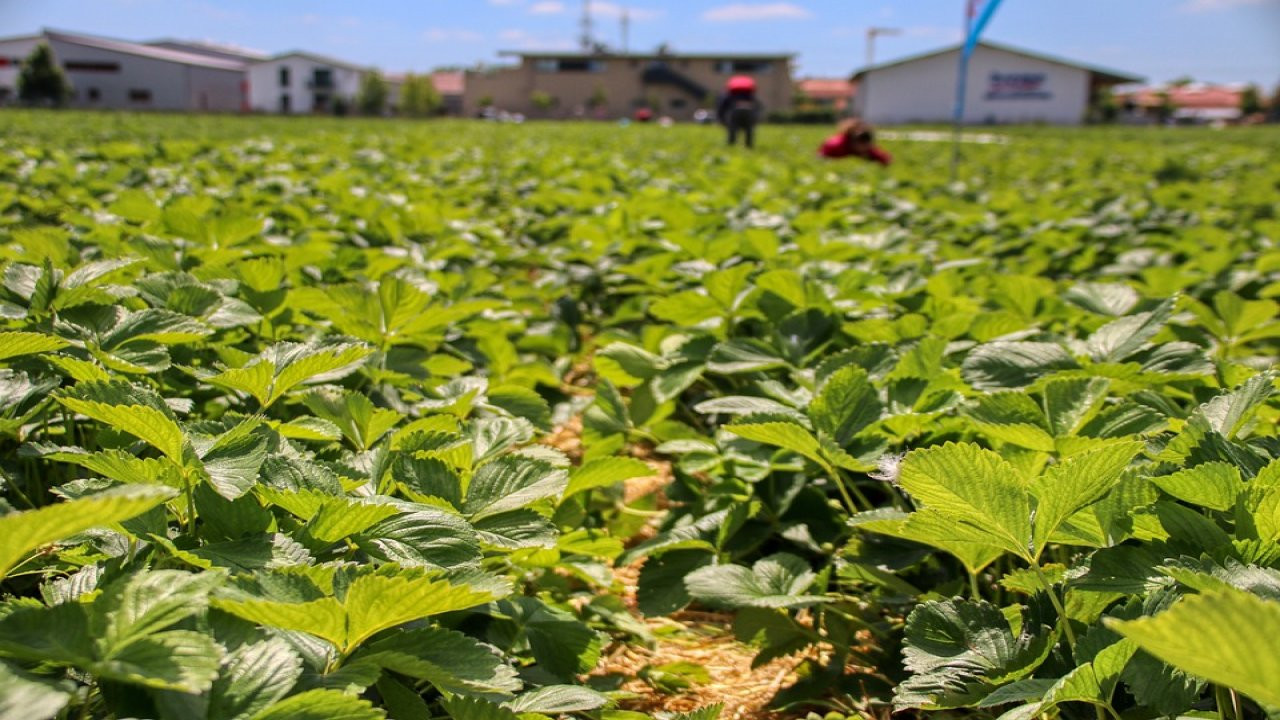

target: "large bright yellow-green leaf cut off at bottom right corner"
[1107,588,1280,707]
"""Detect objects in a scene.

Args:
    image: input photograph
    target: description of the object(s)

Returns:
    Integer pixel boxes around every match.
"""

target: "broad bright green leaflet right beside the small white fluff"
[899,442,1032,560]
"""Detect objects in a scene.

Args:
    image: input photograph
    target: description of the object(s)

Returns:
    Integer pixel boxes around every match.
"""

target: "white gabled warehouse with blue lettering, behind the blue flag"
[854,41,1142,124]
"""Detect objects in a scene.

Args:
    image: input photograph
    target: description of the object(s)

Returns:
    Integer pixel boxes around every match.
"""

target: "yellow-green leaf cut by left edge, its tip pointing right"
[0,486,175,577]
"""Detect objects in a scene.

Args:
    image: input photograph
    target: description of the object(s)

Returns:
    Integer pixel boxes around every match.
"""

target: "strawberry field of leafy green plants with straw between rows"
[0,111,1280,720]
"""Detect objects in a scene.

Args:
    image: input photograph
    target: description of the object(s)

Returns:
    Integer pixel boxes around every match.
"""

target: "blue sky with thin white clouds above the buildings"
[0,0,1280,88]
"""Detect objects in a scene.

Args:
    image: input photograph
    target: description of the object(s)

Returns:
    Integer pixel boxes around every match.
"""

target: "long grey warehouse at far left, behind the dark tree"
[0,29,246,113]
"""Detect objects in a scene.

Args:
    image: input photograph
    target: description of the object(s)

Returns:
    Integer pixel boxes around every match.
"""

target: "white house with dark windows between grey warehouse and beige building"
[248,50,371,115]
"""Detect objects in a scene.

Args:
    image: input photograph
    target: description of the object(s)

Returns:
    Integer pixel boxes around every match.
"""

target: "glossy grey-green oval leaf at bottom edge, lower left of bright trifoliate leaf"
[209,638,302,720]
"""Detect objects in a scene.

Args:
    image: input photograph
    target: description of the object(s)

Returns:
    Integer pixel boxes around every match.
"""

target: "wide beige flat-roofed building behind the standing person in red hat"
[463,51,795,120]
